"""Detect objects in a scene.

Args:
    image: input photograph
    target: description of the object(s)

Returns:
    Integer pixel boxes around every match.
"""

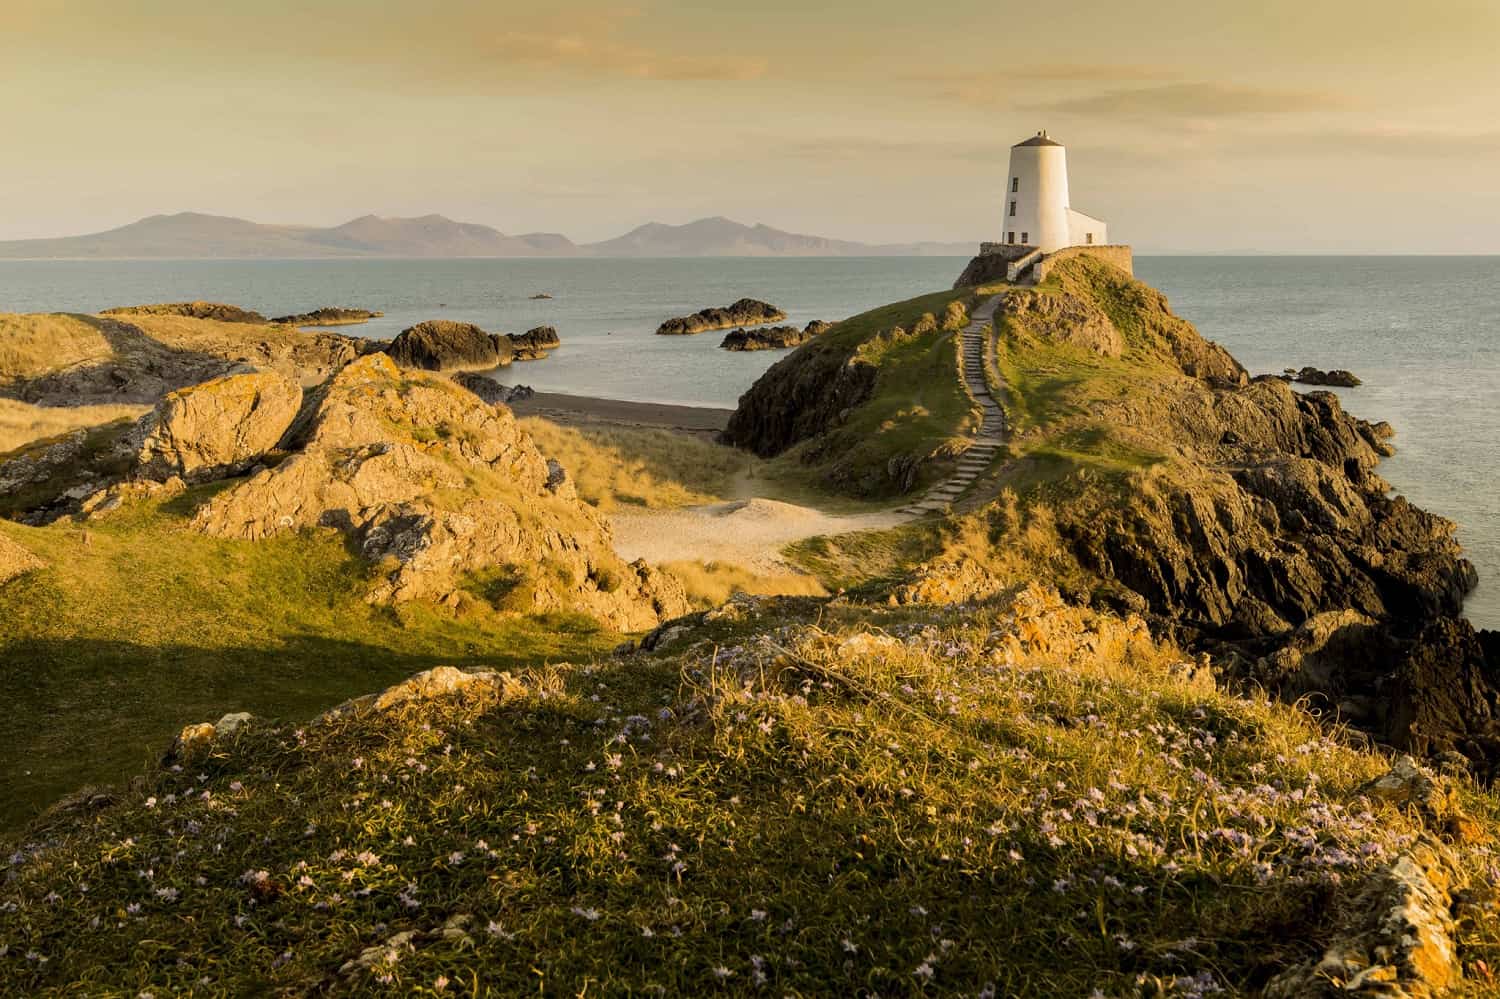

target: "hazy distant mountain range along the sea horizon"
[0,212,977,260]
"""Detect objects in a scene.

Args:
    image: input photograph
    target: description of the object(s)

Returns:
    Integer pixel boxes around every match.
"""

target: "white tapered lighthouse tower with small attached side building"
[1002,132,1109,254]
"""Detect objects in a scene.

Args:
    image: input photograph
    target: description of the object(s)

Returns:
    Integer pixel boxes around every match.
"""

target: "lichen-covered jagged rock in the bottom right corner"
[1265,840,1463,999]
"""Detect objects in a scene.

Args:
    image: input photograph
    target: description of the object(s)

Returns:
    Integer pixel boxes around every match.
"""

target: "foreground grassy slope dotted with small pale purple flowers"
[0,594,1500,996]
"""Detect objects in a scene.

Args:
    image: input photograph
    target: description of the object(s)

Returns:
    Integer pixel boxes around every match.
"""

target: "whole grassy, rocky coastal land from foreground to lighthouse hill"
[0,254,1500,996]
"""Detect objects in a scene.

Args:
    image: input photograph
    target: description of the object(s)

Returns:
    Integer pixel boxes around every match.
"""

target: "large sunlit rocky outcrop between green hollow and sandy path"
[194,354,687,630]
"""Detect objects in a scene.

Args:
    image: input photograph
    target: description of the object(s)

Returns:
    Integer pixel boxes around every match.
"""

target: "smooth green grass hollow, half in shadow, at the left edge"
[0,494,618,828]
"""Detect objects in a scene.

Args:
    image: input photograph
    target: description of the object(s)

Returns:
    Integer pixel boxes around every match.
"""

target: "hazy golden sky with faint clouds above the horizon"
[0,0,1500,254]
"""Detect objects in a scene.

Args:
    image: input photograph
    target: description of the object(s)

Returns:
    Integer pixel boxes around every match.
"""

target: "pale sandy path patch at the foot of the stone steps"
[609,500,909,573]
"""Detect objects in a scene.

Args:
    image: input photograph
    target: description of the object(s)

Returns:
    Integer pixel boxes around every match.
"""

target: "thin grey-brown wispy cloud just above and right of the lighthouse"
[1023,83,1355,119]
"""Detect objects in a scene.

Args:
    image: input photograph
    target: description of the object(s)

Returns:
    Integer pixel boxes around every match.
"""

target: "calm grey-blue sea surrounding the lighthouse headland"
[0,257,1500,629]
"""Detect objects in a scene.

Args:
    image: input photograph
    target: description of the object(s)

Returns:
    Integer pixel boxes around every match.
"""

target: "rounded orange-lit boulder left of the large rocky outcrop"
[137,371,302,482]
